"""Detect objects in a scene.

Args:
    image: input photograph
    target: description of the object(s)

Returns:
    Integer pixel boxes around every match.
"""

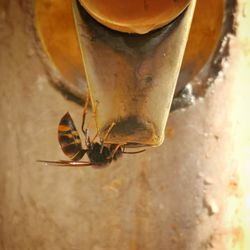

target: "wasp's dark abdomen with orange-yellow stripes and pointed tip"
[58,112,87,161]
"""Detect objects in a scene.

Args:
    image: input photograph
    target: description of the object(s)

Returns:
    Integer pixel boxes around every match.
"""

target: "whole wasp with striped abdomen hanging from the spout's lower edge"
[38,95,145,167]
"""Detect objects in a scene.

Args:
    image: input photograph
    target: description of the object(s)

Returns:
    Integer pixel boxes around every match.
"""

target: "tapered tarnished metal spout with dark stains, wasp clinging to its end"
[73,0,196,146]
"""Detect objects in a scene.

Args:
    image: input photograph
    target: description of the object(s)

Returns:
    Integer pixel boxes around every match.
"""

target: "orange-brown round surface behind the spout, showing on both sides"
[35,0,224,101]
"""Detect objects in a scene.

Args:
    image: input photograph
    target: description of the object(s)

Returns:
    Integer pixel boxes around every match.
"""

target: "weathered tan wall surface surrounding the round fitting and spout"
[0,0,250,250]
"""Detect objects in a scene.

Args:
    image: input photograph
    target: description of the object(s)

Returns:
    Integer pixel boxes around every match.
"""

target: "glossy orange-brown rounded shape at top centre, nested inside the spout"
[80,0,190,34]
